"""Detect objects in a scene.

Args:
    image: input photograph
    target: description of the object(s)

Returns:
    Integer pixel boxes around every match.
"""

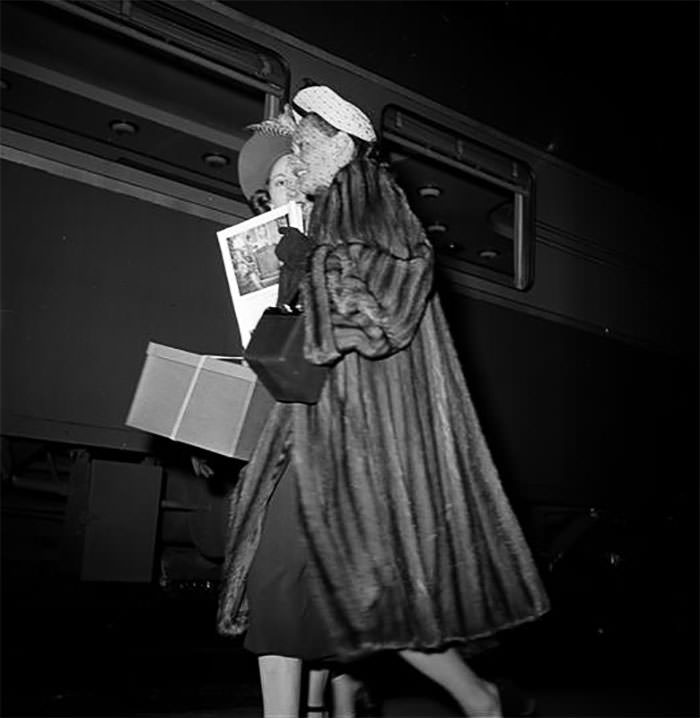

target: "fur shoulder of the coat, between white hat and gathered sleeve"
[309,157,427,258]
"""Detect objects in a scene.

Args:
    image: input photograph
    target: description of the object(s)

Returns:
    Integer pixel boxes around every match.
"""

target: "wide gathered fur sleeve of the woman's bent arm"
[303,241,433,364]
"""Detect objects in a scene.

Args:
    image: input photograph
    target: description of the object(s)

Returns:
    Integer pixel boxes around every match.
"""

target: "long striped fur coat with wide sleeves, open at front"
[218,163,548,658]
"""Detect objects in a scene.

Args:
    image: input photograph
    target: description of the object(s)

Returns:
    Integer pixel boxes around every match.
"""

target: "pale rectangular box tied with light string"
[126,342,275,461]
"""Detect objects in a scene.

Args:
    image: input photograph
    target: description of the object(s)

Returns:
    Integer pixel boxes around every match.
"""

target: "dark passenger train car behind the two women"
[0,0,697,664]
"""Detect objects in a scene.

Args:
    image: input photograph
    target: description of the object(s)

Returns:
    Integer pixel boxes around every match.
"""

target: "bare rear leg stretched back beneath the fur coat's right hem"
[399,648,502,718]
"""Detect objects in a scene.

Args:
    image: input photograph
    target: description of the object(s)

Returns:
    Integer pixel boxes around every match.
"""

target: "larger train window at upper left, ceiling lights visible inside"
[2,2,287,202]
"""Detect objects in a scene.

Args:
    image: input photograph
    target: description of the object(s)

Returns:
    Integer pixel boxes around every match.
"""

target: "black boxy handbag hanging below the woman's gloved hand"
[243,308,329,404]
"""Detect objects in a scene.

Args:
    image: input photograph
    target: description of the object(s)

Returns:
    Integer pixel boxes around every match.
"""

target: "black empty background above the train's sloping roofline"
[231,0,700,217]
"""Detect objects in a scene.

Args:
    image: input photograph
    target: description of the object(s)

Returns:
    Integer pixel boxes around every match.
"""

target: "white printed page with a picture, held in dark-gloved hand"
[216,202,304,349]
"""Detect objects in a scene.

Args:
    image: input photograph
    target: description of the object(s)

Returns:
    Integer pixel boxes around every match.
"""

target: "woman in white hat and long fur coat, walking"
[219,87,548,717]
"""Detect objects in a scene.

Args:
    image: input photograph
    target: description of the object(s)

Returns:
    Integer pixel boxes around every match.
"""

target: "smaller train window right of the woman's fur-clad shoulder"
[382,106,535,290]
